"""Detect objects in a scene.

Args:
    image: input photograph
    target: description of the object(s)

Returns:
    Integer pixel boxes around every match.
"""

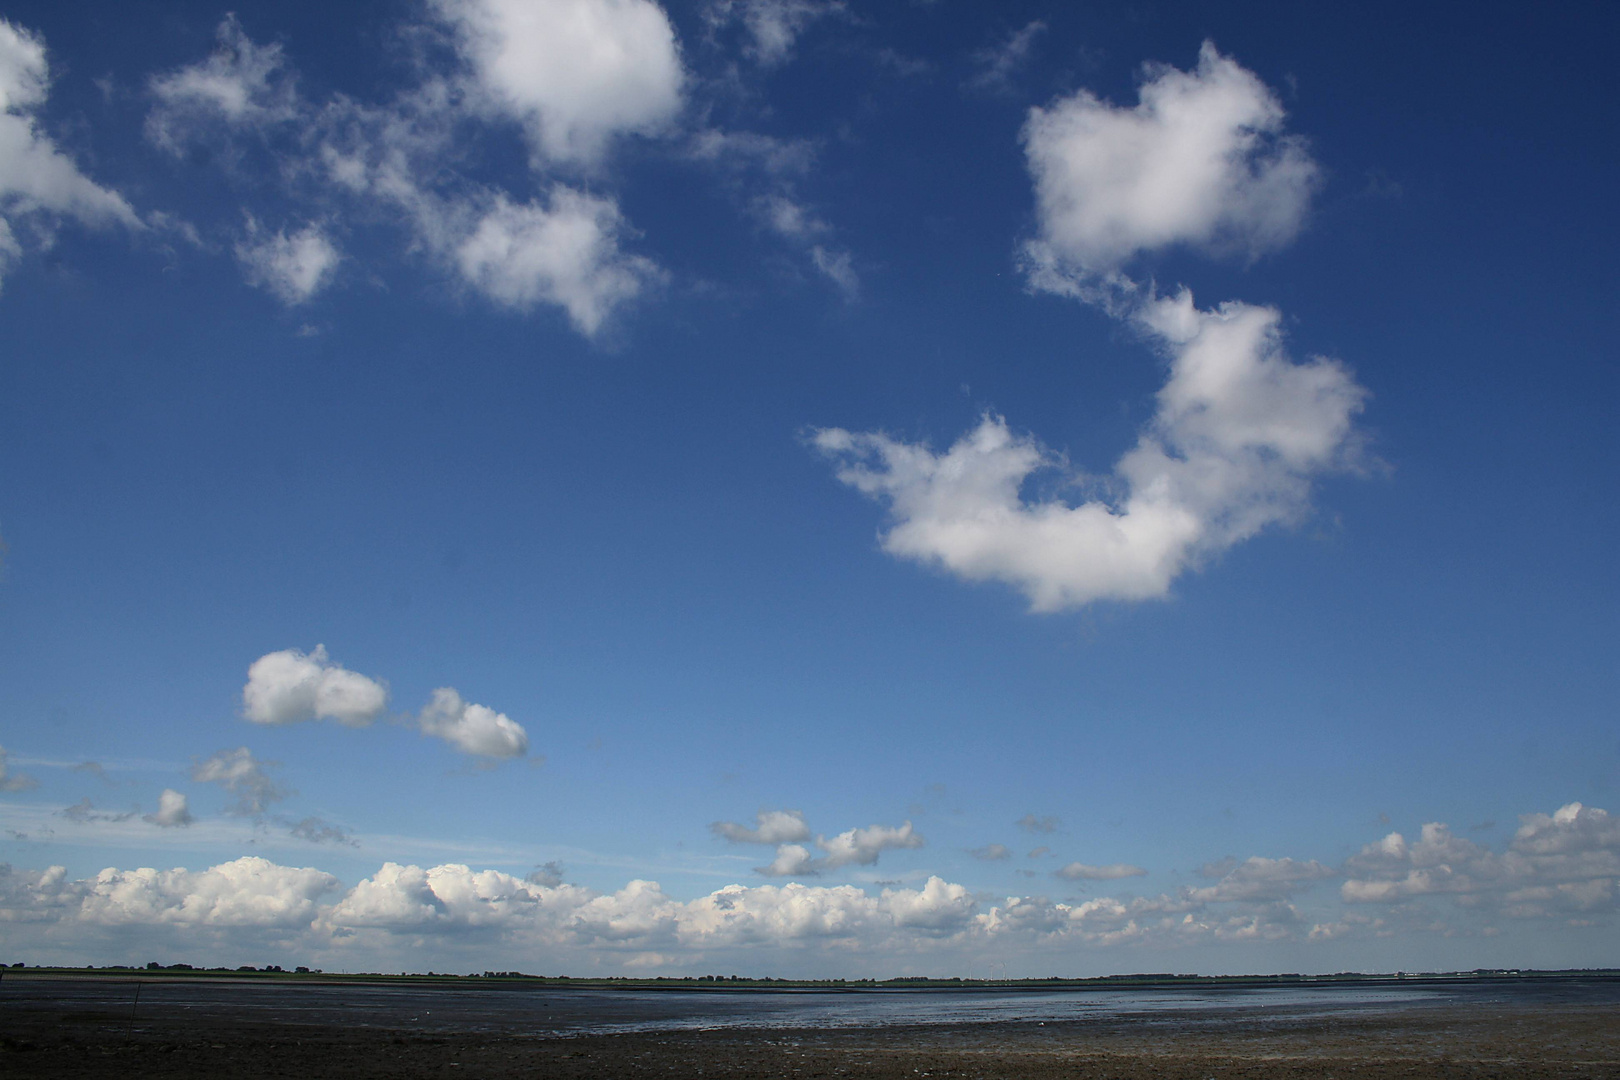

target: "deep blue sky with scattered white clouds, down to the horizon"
[0,0,1620,976]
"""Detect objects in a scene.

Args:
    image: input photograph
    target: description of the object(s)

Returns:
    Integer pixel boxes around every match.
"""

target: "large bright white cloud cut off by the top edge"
[434,0,685,162]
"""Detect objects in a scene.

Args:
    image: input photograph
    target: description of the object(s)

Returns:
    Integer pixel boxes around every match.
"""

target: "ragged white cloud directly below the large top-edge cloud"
[455,185,663,337]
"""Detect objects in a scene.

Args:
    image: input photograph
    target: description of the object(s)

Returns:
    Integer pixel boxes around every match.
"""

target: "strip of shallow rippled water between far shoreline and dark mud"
[0,978,1620,1035]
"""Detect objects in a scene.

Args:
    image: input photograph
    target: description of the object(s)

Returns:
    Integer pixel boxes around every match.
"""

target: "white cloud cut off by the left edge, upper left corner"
[0,19,141,291]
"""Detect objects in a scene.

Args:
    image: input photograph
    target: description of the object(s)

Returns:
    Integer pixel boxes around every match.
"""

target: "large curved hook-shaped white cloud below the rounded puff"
[813,291,1366,612]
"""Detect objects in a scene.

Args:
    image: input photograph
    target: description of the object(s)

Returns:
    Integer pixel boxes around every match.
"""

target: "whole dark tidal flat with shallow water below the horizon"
[0,975,1620,1080]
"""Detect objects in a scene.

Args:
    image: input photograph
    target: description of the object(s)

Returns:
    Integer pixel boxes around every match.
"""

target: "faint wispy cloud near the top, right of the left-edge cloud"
[146,15,300,154]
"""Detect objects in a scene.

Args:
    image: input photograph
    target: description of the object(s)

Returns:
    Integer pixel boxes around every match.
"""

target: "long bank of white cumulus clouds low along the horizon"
[0,803,1620,975]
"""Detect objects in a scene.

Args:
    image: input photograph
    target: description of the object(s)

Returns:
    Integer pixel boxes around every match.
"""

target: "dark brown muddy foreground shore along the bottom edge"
[0,977,1620,1080]
